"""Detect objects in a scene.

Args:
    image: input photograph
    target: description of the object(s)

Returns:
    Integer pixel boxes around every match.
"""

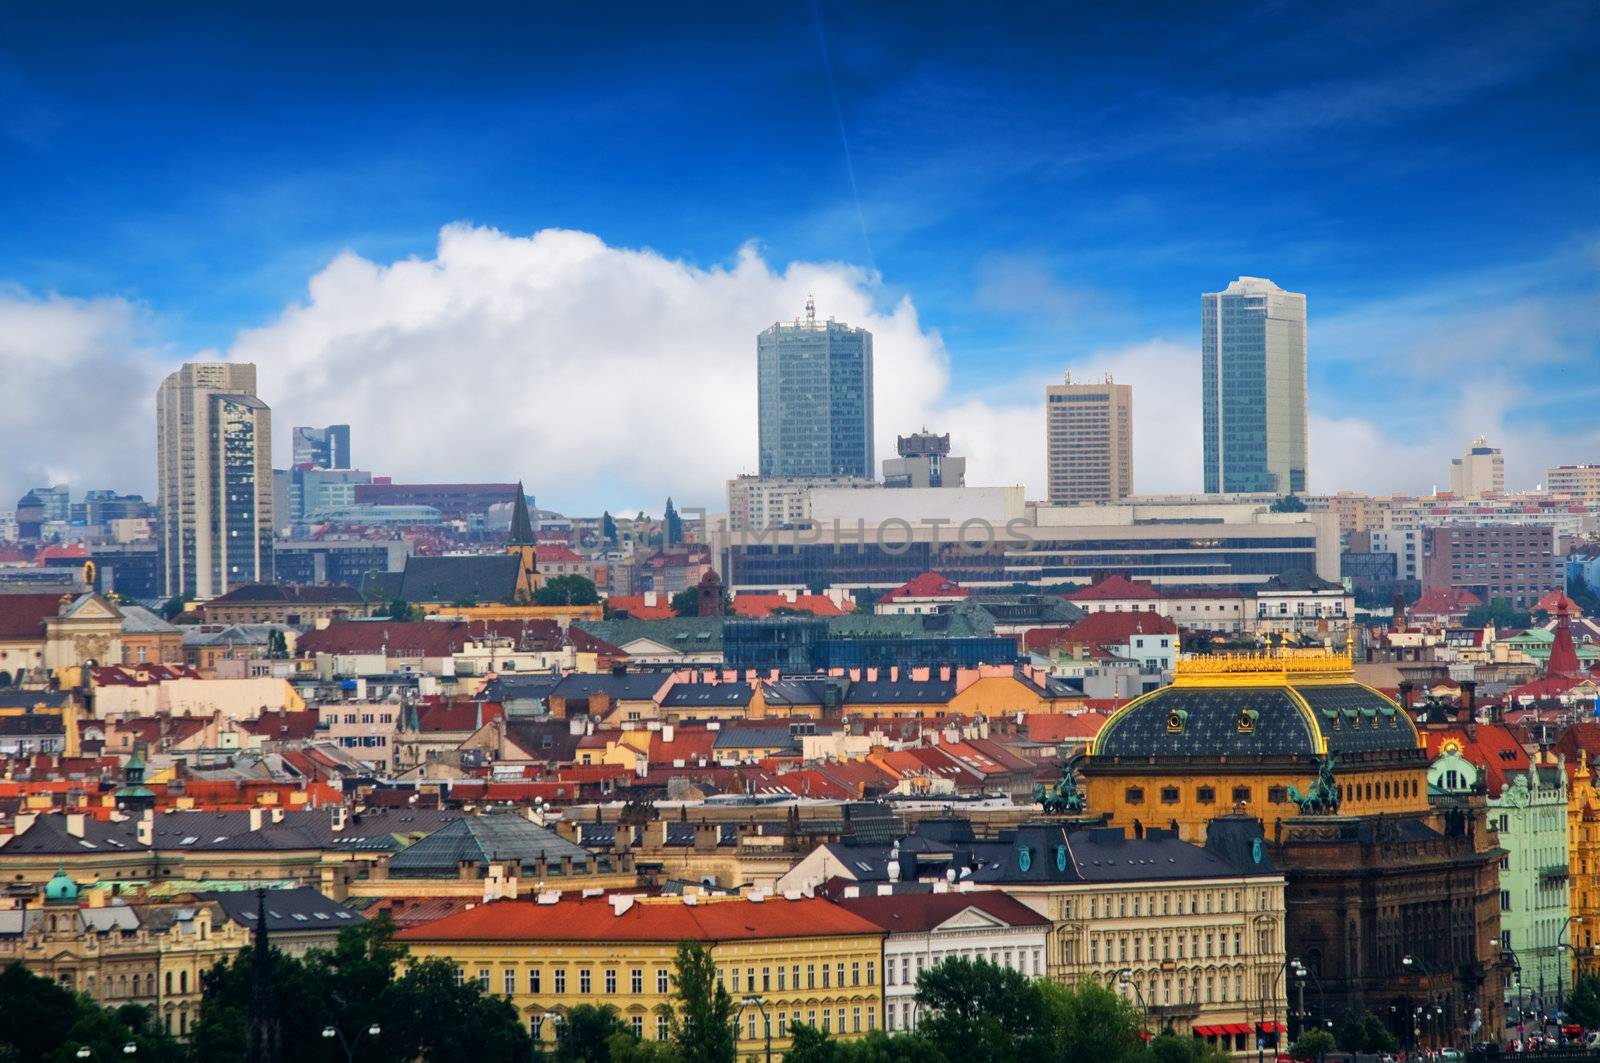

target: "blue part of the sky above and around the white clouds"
[0,3,1600,504]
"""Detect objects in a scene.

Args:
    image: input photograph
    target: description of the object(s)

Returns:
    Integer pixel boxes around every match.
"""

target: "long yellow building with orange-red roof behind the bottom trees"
[397,895,883,1057]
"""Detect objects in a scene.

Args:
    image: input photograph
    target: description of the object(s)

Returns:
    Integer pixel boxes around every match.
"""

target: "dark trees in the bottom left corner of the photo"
[0,964,184,1063]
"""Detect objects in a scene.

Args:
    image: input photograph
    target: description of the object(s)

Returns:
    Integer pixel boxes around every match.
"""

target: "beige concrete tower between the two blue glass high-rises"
[1045,373,1133,506]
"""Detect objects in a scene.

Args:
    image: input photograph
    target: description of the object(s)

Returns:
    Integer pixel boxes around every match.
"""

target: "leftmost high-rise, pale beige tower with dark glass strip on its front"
[155,362,272,599]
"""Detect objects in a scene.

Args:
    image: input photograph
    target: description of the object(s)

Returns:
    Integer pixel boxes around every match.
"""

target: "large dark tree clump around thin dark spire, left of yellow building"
[190,917,530,1063]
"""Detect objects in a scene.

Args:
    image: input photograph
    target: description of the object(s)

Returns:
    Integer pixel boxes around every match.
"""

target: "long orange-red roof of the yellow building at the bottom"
[395,897,883,941]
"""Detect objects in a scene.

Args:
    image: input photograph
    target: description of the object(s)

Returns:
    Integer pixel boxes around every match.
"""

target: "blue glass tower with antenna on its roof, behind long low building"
[755,296,877,479]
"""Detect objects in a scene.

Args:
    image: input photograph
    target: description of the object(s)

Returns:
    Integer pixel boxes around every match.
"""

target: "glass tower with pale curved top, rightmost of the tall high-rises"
[1200,277,1306,495]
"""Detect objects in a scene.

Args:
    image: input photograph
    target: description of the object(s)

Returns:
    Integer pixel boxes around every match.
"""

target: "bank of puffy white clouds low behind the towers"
[0,226,1600,514]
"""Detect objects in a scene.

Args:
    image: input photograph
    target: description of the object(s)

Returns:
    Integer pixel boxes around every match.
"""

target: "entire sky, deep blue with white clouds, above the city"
[0,3,1600,511]
